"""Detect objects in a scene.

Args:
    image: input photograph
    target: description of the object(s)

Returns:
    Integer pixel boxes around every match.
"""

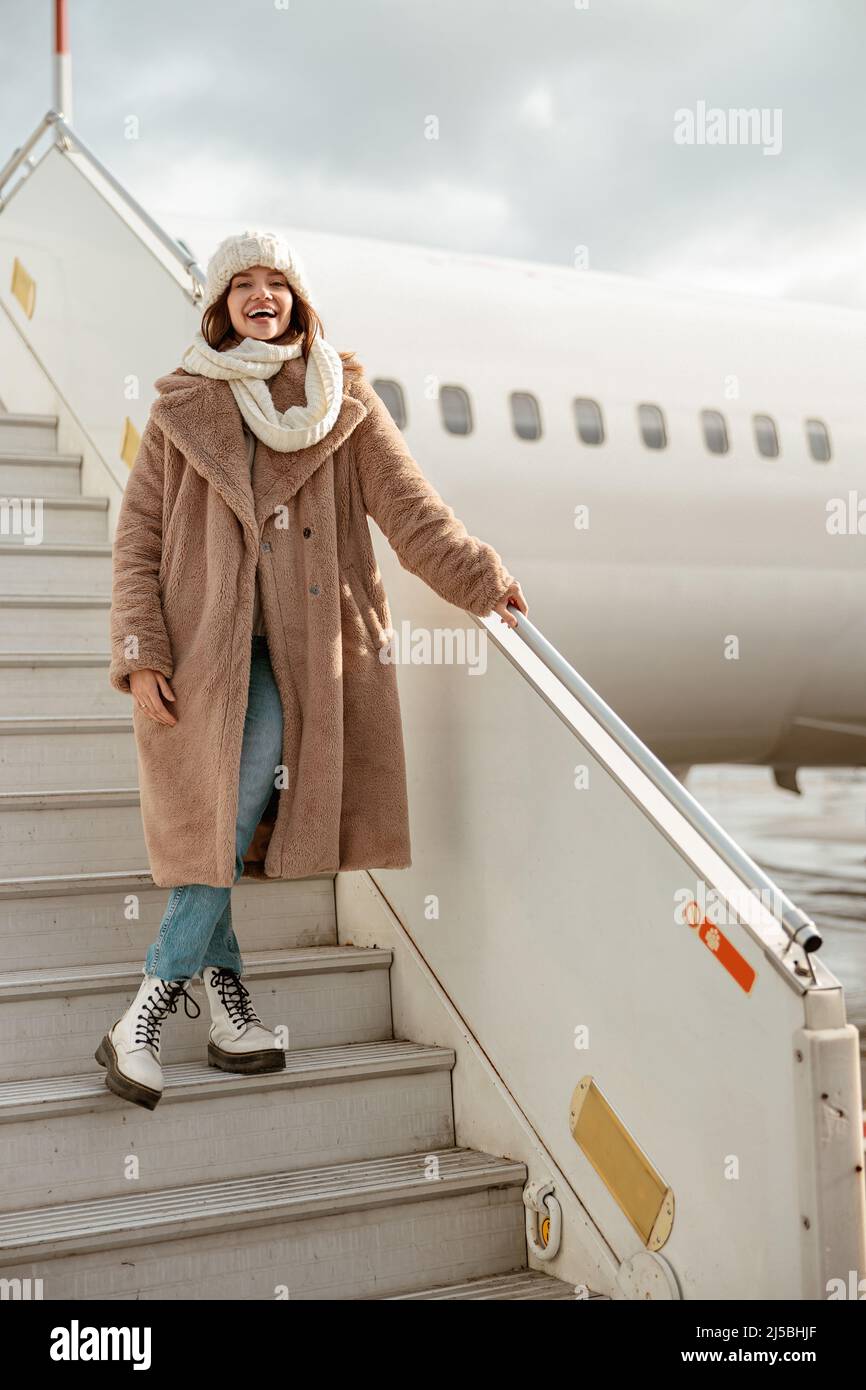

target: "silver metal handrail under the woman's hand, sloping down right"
[475,607,823,952]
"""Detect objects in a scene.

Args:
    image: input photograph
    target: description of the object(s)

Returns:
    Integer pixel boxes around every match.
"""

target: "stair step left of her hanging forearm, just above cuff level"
[0,597,111,656]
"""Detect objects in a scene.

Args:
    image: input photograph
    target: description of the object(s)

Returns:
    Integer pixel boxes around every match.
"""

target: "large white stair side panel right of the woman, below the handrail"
[371,535,863,1298]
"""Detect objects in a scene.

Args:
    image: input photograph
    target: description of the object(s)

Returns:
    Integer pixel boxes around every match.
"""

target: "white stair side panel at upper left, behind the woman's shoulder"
[0,147,200,534]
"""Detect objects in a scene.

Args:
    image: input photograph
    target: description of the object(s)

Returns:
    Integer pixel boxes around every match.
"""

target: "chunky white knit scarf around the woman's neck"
[183,331,343,453]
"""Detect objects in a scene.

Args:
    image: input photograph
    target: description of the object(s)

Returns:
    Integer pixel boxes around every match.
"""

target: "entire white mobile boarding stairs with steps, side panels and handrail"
[0,113,866,1301]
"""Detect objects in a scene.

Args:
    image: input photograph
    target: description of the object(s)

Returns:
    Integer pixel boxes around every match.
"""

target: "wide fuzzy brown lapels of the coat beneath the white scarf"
[152,357,367,542]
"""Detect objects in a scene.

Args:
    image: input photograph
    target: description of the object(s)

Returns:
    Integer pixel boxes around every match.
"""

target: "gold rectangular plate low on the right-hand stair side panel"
[570,1076,674,1250]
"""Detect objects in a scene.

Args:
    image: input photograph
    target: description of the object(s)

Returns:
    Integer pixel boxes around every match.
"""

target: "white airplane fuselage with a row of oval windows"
[304,229,866,790]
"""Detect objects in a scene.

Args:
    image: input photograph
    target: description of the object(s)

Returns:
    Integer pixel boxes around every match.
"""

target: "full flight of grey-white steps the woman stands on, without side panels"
[0,414,592,1300]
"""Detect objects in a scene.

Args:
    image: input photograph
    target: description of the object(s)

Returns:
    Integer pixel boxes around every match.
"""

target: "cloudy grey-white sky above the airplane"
[0,0,866,307]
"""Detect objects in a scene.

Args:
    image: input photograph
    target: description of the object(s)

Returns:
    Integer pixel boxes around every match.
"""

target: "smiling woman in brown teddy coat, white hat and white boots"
[104,231,527,1109]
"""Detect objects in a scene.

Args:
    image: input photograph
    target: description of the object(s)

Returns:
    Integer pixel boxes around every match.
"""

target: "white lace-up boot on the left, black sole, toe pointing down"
[95,974,202,1111]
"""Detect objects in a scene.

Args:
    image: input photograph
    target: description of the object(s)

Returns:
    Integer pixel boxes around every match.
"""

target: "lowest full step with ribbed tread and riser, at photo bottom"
[0,1148,527,1300]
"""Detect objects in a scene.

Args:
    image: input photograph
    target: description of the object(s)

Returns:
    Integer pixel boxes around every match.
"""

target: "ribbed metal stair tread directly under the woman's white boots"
[0,1038,455,1120]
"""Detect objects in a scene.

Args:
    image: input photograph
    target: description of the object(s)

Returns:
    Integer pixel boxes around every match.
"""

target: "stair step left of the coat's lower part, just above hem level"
[0,787,149,878]
